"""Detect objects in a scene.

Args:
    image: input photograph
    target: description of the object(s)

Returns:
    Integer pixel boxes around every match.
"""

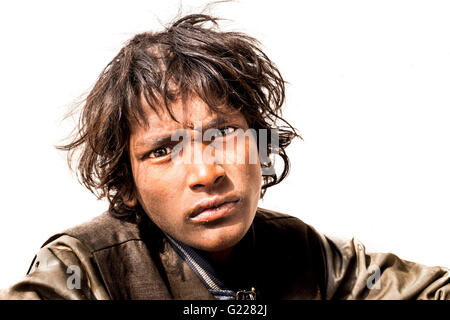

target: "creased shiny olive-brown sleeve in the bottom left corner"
[0,235,109,300]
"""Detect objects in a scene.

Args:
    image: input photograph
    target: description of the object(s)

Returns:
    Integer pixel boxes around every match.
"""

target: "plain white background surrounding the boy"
[0,0,450,287]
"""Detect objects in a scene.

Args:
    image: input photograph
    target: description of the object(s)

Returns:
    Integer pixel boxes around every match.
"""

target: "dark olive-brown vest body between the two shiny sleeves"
[46,209,325,300]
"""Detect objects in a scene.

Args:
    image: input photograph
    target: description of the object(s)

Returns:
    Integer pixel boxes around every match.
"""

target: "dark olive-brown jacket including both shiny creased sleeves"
[0,209,450,300]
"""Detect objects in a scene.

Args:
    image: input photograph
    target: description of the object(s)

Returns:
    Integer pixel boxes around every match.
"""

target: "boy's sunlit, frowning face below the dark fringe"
[129,97,261,252]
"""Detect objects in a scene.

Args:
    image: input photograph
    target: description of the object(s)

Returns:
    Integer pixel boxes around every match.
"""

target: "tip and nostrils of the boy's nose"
[188,143,225,191]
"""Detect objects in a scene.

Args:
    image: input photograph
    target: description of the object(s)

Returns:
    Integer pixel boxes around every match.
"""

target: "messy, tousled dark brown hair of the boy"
[58,14,298,220]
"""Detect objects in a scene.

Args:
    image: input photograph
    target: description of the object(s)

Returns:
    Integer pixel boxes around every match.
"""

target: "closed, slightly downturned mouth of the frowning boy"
[188,197,240,223]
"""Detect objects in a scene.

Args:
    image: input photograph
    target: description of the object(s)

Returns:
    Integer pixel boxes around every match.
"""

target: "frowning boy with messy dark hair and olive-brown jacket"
[3,14,450,300]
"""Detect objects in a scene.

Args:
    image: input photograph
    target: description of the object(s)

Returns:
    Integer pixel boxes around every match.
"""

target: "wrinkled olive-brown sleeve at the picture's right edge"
[321,235,450,300]
